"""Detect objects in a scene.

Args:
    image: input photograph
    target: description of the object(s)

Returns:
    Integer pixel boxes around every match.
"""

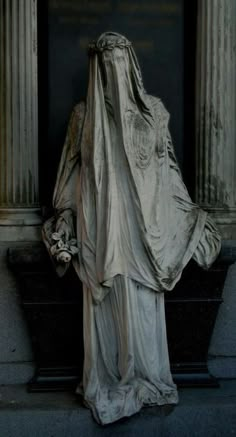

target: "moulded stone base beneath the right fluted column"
[201,205,236,240]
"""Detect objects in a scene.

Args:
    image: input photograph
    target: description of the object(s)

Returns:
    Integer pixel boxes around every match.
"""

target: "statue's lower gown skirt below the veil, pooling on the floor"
[77,276,178,425]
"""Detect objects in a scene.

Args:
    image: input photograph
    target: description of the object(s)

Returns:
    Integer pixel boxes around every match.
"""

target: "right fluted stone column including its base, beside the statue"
[196,0,236,239]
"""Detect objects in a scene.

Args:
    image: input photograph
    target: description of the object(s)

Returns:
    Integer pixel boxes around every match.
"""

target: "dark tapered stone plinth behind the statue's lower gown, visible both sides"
[8,243,232,392]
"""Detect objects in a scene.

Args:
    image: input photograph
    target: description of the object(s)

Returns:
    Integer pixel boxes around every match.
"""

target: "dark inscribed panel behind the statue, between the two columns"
[38,0,196,205]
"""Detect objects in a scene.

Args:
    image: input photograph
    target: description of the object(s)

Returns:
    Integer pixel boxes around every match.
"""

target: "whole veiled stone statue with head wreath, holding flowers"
[43,32,220,424]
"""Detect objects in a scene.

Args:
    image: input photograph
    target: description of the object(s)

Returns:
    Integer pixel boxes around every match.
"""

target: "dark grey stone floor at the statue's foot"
[0,380,236,437]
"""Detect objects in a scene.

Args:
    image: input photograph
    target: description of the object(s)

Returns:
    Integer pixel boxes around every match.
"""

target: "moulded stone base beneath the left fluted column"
[0,208,42,241]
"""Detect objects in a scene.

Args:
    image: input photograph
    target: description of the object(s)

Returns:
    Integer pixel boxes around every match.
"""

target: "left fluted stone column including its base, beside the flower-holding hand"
[0,0,41,240]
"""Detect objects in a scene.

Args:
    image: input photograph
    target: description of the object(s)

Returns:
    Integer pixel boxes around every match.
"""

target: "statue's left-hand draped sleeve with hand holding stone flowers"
[42,103,85,276]
